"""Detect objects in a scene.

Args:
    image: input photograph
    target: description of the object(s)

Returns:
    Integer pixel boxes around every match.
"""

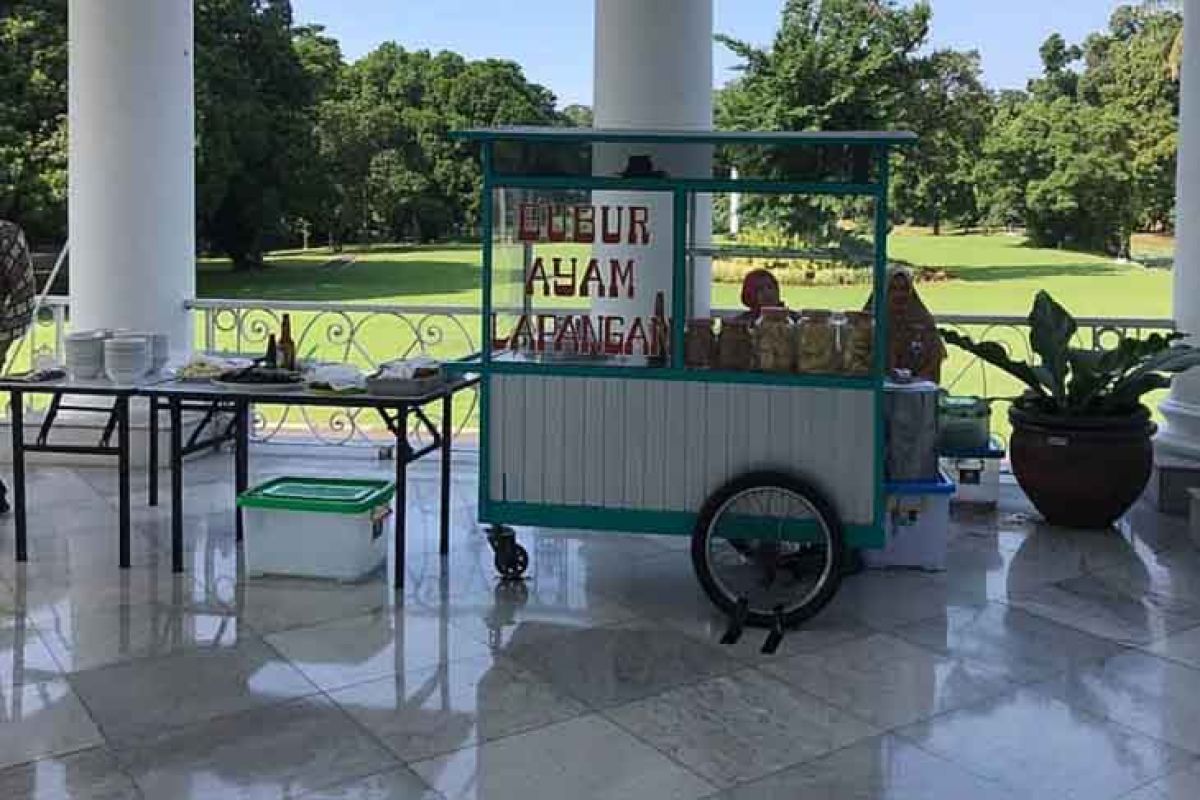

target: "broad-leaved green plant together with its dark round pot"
[942,291,1200,528]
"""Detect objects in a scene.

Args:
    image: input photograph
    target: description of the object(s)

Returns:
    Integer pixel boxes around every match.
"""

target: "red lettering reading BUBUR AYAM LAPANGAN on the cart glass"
[492,203,670,357]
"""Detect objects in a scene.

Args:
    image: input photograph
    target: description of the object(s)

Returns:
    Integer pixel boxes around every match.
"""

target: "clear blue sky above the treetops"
[293,0,1122,104]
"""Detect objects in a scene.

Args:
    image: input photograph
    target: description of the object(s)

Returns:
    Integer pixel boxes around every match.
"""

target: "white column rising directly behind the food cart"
[594,0,713,326]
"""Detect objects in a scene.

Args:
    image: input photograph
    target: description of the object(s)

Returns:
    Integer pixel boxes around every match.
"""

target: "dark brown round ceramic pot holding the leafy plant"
[1008,404,1157,528]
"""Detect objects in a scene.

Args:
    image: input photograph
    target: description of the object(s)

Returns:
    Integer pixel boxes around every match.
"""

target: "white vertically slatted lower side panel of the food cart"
[488,374,877,524]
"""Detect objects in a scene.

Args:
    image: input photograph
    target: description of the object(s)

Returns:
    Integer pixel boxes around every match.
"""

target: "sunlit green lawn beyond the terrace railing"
[198,231,1171,317]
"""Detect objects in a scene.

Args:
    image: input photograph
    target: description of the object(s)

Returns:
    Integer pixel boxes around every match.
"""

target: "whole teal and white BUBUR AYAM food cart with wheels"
[455,127,916,630]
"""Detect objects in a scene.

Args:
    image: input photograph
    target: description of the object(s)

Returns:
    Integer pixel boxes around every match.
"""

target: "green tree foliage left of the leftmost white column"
[0,0,67,241]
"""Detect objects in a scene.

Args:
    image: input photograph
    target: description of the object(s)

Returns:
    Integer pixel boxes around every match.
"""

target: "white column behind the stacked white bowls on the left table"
[68,0,196,355]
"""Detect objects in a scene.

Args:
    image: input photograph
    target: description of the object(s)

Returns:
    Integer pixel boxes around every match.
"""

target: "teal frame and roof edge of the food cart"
[452,127,917,563]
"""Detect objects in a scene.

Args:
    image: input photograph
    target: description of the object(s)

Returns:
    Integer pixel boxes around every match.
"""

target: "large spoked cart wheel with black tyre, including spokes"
[691,473,846,627]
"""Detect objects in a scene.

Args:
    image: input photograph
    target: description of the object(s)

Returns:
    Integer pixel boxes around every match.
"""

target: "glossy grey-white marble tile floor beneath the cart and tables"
[0,453,1200,800]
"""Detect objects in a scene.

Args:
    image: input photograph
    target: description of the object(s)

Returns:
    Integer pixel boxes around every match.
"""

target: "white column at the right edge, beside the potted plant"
[1158,0,1200,461]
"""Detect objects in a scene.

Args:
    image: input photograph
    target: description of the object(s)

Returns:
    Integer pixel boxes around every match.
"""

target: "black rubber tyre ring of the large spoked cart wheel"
[691,471,846,627]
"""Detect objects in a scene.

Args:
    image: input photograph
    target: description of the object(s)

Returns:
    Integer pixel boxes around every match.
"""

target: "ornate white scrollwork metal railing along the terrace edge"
[5,297,1174,446]
